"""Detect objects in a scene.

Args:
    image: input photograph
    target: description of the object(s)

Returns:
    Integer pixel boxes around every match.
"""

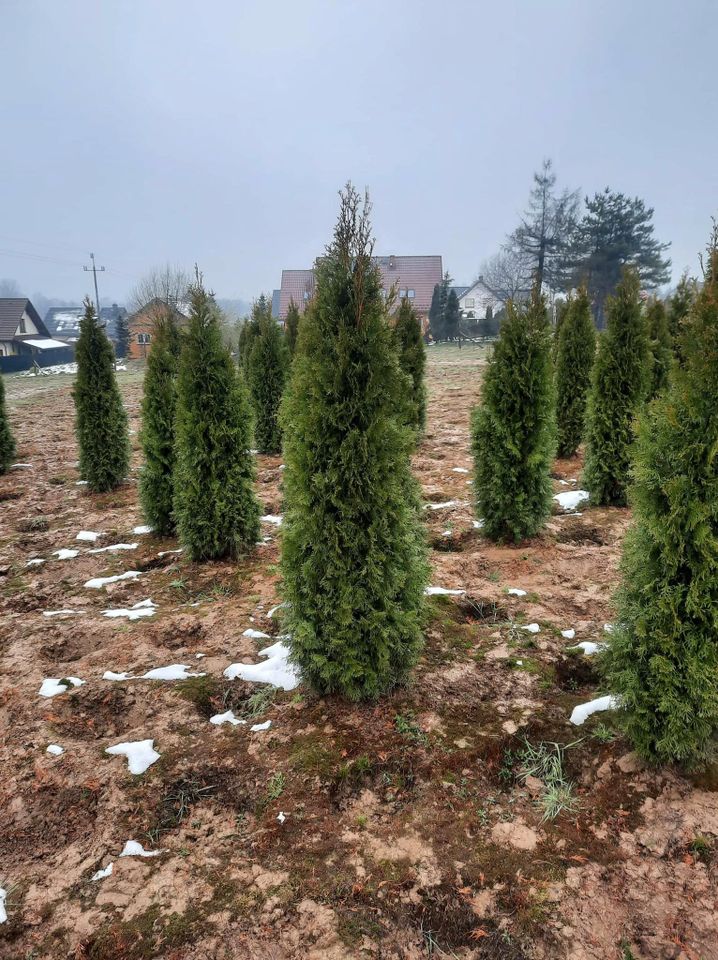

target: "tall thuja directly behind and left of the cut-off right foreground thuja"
[584,269,650,507]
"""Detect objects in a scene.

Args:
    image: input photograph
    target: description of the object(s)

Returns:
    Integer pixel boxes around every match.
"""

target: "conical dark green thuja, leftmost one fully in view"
[73,298,130,493]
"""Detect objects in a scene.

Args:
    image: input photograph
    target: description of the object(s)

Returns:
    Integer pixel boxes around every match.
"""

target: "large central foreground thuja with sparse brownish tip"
[281,185,428,700]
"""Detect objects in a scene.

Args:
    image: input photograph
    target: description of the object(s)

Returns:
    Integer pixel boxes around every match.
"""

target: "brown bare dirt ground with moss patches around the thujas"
[0,347,718,960]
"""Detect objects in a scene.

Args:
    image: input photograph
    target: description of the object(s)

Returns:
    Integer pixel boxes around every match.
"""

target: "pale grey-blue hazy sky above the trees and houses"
[0,0,718,299]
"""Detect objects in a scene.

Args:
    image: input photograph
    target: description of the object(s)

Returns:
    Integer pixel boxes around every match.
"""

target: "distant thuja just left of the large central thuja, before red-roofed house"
[247,314,289,453]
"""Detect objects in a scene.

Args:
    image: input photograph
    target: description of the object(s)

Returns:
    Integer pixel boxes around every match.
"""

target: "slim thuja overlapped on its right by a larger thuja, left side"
[140,311,179,536]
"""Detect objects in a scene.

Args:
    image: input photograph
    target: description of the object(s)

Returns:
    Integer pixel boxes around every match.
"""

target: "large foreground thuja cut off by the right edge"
[604,235,718,766]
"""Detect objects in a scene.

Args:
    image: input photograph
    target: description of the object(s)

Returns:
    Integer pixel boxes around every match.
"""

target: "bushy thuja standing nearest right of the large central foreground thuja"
[472,289,556,541]
